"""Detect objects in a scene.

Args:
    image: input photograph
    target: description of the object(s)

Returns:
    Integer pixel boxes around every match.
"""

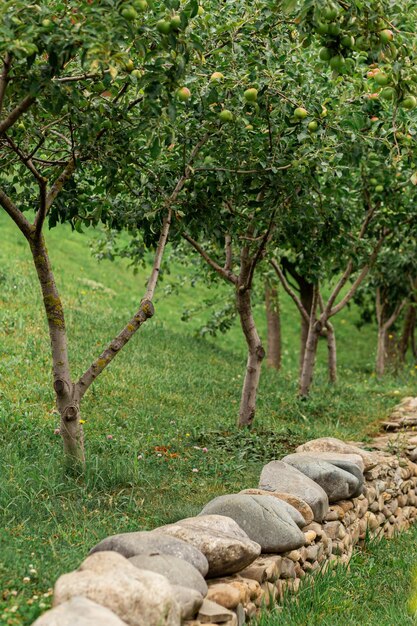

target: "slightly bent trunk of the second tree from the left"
[236,287,265,427]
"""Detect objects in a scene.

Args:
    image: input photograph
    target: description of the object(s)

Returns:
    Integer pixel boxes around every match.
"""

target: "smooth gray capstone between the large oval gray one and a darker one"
[259,461,329,522]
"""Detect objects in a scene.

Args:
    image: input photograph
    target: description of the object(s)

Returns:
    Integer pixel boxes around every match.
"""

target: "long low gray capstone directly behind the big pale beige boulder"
[90,531,208,576]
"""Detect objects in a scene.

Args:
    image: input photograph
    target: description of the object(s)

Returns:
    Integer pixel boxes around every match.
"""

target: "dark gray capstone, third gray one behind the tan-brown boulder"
[282,458,359,502]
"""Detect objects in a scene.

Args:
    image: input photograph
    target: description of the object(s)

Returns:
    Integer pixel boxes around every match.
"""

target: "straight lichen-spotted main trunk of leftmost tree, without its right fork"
[29,233,85,469]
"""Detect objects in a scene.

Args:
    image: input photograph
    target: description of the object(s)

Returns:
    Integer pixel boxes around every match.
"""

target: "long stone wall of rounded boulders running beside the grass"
[35,398,417,626]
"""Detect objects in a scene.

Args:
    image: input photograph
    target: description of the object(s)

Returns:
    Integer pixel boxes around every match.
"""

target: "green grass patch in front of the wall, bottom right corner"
[257,528,417,626]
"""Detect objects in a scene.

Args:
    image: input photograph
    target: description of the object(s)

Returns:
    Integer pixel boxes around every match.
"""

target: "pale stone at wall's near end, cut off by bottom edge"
[32,596,126,626]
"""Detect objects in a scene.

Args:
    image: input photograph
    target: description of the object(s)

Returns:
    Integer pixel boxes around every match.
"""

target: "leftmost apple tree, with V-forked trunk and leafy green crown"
[0,0,205,466]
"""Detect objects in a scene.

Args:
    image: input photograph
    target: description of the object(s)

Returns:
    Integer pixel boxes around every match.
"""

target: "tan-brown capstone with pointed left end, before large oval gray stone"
[153,515,261,578]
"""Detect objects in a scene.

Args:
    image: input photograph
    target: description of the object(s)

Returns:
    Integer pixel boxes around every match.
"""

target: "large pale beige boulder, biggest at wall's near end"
[54,552,181,626]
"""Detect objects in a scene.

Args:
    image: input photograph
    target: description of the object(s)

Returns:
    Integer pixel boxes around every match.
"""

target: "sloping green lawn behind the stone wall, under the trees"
[0,214,416,625]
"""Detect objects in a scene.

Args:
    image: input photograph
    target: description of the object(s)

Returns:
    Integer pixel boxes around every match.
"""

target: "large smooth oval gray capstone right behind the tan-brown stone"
[201,494,305,552]
